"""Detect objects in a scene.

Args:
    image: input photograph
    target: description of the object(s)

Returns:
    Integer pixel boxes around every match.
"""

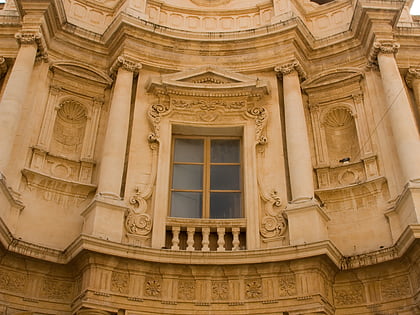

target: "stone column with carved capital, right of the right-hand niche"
[371,42,420,182]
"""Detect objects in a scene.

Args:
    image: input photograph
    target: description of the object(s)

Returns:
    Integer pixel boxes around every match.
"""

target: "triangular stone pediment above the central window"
[147,67,268,96]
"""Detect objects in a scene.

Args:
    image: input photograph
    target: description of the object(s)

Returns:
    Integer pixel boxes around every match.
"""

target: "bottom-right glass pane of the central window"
[210,193,242,219]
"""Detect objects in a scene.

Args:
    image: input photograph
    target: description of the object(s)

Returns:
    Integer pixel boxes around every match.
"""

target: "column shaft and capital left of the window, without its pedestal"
[98,56,141,199]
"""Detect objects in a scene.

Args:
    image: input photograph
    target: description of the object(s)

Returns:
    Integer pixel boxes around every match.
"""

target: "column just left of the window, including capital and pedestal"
[82,56,141,242]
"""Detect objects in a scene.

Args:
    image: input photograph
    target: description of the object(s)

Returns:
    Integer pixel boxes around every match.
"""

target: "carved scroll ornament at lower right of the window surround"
[260,191,287,240]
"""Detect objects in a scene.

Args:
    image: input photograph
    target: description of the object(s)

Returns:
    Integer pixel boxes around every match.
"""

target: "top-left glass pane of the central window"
[174,139,204,163]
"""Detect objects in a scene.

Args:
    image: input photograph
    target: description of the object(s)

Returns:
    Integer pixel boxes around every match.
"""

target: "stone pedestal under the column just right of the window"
[285,200,330,245]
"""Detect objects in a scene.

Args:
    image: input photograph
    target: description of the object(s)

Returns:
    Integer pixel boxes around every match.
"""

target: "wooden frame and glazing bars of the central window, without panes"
[167,133,245,220]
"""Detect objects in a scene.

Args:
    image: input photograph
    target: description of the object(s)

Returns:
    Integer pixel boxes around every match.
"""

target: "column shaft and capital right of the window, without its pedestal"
[275,62,314,203]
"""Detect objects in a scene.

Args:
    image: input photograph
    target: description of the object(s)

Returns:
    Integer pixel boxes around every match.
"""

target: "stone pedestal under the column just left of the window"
[82,194,127,243]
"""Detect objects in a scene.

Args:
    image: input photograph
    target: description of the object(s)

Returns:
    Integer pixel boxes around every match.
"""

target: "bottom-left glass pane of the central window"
[171,191,202,218]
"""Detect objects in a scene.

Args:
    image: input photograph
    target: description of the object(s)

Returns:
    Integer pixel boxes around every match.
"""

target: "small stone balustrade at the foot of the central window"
[165,218,246,252]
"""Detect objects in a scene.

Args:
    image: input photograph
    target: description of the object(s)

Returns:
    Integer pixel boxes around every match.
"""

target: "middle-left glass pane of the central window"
[172,164,203,190]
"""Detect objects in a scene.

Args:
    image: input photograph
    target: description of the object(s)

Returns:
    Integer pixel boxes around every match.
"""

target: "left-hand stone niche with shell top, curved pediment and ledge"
[22,62,112,205]
